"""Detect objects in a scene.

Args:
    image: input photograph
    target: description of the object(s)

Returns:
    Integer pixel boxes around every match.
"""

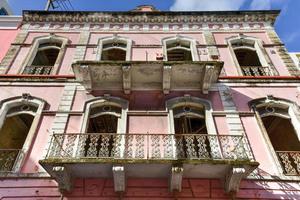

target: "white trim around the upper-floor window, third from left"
[162,35,200,61]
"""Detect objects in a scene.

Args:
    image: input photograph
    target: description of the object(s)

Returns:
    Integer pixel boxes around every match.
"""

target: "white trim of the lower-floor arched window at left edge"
[0,95,46,173]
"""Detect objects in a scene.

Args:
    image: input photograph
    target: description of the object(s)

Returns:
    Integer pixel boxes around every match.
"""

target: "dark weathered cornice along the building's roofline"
[23,10,280,25]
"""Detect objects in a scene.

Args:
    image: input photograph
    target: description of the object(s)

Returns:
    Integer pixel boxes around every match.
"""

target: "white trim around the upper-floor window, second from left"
[96,35,132,61]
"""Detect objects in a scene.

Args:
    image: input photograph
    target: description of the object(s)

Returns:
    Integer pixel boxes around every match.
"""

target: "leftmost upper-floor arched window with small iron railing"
[23,35,68,75]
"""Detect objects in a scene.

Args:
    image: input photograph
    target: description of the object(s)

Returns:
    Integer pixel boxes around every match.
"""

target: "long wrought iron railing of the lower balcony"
[47,133,253,160]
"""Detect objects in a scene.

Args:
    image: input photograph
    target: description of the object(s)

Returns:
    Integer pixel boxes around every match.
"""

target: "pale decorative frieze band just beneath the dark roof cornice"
[22,22,269,32]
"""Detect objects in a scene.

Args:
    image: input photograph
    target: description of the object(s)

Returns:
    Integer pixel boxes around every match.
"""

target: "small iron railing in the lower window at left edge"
[0,149,21,172]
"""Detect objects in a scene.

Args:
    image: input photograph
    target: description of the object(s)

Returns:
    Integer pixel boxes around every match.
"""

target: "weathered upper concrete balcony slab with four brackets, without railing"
[72,61,223,94]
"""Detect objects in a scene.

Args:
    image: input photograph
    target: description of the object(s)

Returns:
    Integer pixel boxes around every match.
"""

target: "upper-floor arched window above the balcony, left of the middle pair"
[97,35,132,61]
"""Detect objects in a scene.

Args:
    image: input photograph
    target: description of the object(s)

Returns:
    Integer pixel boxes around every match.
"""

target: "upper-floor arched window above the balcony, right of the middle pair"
[162,35,199,61]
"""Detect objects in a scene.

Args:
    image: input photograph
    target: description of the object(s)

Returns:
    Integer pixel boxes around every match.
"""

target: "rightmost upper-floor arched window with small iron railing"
[227,35,276,76]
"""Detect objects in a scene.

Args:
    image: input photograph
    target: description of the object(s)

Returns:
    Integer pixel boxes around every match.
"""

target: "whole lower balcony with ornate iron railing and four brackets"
[40,133,258,192]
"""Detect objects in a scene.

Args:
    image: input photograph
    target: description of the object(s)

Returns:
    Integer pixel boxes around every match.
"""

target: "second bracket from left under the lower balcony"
[112,165,126,192]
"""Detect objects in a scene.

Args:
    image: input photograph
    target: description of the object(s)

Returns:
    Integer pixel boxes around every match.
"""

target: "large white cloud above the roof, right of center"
[170,0,247,11]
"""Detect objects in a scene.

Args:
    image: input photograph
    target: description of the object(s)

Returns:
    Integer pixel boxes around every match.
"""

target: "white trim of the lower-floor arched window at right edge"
[249,96,300,180]
